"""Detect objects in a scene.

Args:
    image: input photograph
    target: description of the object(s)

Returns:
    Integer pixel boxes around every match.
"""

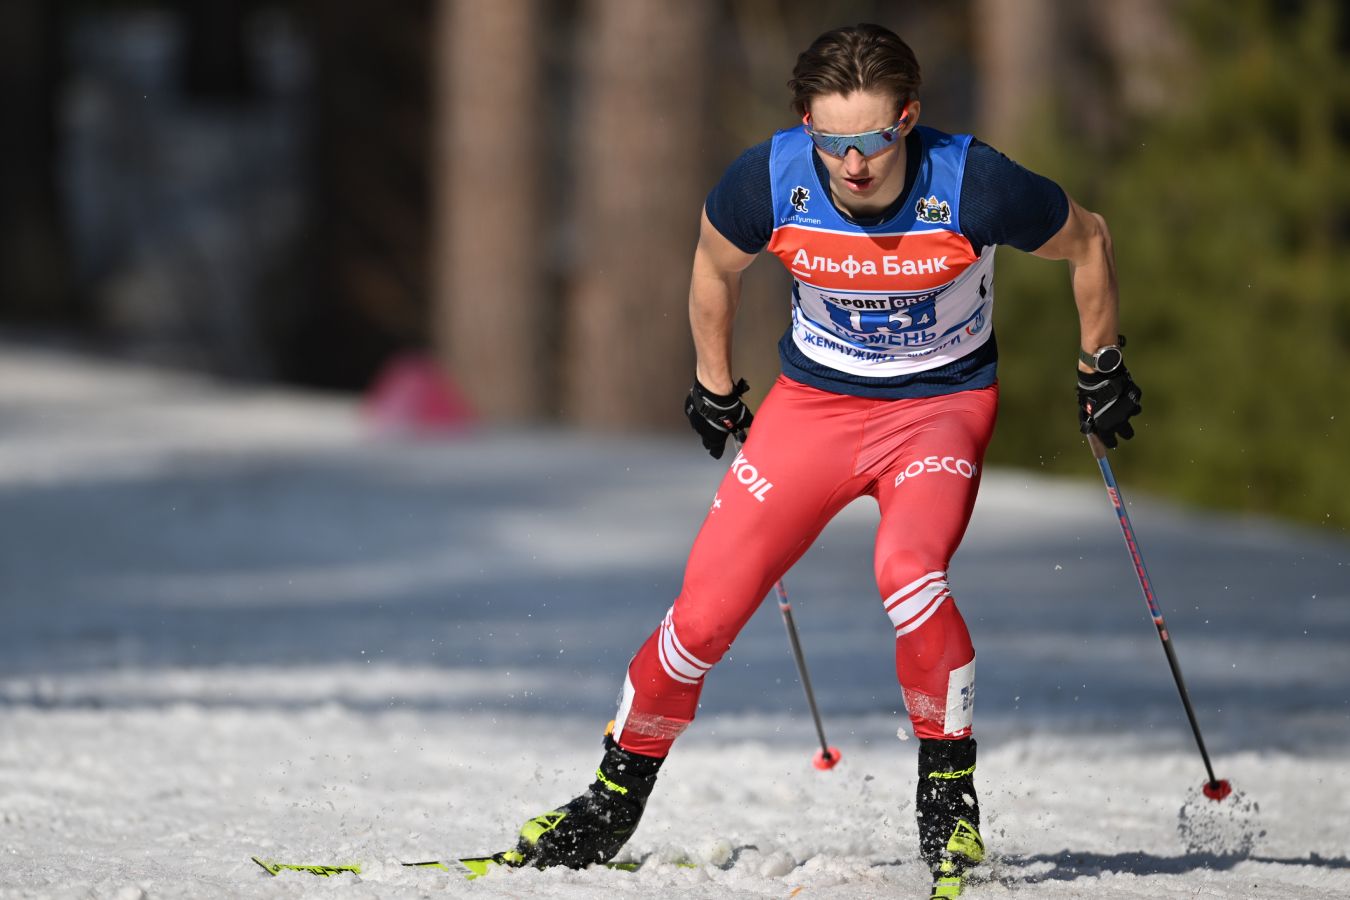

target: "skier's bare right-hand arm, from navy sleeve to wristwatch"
[1033,198,1119,372]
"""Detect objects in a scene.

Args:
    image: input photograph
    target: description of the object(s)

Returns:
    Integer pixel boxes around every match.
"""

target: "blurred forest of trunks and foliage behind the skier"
[0,0,1350,533]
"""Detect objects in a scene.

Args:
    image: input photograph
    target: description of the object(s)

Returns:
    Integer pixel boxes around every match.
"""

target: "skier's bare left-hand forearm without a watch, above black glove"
[689,212,755,394]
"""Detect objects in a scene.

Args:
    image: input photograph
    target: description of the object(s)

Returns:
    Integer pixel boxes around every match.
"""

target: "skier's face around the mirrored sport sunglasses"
[807,90,919,215]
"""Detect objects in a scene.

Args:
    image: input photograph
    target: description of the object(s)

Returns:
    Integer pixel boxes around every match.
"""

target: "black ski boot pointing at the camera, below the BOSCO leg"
[915,738,984,897]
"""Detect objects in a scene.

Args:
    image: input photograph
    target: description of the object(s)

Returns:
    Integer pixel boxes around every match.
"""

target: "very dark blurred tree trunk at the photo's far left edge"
[0,0,77,321]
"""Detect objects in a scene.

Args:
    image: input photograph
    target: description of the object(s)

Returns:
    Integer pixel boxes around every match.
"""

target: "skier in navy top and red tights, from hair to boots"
[502,24,1141,897]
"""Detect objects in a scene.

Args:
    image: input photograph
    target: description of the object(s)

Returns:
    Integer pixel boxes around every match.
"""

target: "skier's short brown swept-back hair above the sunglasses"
[787,23,923,116]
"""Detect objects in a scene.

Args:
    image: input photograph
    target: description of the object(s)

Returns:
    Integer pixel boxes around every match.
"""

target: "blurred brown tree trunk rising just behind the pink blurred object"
[431,0,542,420]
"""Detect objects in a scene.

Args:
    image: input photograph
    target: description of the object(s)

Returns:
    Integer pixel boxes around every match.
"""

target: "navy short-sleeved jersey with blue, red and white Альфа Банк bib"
[705,127,1068,398]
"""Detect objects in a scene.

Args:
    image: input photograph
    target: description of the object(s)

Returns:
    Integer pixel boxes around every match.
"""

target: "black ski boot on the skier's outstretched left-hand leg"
[505,735,666,869]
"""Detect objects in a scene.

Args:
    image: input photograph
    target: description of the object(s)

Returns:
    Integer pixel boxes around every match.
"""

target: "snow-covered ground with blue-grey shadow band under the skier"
[0,345,1350,900]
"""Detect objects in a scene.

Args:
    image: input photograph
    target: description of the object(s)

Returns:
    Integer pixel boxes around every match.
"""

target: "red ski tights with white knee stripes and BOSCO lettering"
[614,376,998,757]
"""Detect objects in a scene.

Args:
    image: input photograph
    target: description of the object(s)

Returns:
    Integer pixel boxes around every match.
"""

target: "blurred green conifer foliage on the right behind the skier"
[992,0,1350,533]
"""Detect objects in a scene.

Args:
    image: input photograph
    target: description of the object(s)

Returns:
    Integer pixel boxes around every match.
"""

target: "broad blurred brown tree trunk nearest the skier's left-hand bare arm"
[563,0,713,426]
